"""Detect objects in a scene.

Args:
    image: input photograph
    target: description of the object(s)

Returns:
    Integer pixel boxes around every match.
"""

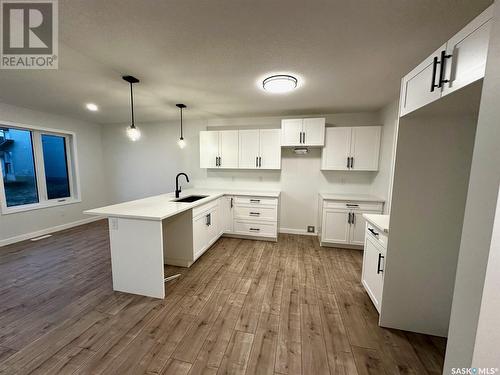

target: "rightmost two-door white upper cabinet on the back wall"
[321,126,382,171]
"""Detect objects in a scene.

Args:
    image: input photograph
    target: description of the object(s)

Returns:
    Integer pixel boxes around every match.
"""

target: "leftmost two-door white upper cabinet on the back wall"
[200,130,238,168]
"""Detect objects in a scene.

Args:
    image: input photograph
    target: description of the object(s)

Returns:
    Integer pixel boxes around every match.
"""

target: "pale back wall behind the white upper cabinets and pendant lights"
[99,111,387,233]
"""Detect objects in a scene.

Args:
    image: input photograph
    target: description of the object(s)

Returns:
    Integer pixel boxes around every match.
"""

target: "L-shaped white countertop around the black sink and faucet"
[83,188,280,220]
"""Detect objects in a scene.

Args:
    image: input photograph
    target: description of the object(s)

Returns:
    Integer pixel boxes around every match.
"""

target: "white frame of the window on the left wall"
[0,120,82,215]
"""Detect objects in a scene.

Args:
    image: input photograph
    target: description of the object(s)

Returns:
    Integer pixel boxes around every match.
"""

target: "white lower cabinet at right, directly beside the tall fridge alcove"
[361,223,387,313]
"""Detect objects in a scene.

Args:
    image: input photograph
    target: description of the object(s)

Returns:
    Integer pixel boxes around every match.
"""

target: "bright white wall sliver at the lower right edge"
[472,187,500,368]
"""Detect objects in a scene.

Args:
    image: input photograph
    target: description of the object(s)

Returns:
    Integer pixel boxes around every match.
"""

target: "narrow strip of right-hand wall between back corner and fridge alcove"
[371,100,399,214]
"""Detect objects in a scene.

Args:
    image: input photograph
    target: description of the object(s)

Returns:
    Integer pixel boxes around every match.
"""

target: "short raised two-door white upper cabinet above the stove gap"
[281,118,325,147]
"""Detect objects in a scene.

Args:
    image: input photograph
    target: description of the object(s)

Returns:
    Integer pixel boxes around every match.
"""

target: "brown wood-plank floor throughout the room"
[0,221,445,375]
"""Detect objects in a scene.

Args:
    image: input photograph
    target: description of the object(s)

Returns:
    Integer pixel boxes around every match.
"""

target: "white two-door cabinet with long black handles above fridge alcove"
[400,6,493,116]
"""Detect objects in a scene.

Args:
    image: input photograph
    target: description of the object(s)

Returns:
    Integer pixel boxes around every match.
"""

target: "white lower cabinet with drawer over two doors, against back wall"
[320,200,383,247]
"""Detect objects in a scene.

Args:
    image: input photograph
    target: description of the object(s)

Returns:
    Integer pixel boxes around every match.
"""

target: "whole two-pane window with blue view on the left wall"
[0,123,79,214]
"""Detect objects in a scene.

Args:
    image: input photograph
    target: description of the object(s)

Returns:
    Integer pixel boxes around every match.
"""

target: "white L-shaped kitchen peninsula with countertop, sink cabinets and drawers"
[84,189,280,298]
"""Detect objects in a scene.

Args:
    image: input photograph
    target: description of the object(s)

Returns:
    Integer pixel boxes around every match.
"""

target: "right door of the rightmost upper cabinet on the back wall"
[351,126,382,171]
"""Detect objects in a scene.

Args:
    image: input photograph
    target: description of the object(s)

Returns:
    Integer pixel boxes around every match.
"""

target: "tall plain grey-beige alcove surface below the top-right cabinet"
[380,109,477,336]
